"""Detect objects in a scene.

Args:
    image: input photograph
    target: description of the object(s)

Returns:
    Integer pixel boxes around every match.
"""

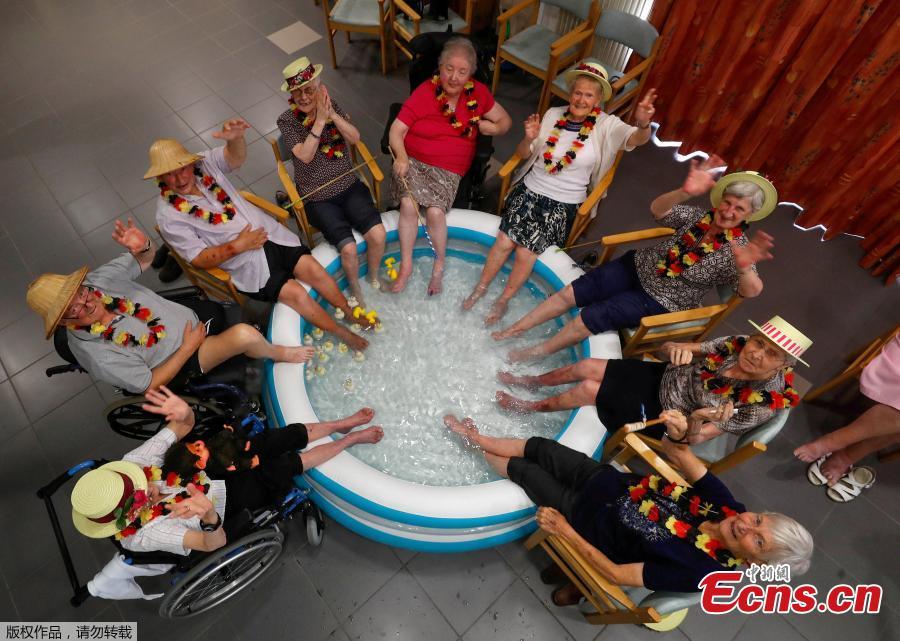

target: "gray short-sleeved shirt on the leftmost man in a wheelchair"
[67,254,197,392]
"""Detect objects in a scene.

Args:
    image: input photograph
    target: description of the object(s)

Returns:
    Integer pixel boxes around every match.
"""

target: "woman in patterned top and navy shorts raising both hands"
[493,156,778,361]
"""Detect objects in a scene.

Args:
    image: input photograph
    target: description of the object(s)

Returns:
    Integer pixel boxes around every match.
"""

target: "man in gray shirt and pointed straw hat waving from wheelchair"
[27,220,314,393]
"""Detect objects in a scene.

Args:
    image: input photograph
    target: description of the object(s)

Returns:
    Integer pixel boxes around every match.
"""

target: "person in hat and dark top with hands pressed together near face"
[278,56,385,307]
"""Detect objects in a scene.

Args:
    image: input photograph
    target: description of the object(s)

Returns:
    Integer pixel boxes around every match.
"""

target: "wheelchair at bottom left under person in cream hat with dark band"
[37,459,325,619]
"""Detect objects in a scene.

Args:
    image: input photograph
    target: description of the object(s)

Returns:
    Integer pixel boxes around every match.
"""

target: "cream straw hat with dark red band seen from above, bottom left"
[72,461,147,539]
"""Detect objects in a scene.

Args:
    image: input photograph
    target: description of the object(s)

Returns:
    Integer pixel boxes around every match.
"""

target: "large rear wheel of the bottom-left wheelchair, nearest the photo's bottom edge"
[159,528,284,619]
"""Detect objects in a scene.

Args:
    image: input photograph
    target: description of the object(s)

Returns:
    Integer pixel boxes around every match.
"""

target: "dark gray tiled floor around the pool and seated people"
[0,0,900,641]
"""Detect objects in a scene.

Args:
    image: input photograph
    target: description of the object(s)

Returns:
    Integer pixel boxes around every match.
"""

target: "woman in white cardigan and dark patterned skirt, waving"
[463,62,656,326]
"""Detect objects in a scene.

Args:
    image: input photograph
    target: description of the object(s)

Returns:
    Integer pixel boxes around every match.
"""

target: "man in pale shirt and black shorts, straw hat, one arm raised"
[144,118,369,350]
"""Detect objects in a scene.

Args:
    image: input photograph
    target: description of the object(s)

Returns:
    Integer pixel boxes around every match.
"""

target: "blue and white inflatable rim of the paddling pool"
[264,209,622,552]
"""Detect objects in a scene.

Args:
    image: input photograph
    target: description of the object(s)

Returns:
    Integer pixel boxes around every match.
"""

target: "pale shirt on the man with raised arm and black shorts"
[156,147,301,294]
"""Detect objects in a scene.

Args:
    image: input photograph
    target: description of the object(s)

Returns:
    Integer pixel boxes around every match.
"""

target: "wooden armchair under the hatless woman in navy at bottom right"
[525,434,700,632]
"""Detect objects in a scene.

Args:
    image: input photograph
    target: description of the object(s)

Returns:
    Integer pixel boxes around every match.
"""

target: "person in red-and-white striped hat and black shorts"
[497,316,812,444]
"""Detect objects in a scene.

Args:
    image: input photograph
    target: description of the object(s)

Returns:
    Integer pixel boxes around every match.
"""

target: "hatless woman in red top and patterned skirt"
[389,38,512,295]
